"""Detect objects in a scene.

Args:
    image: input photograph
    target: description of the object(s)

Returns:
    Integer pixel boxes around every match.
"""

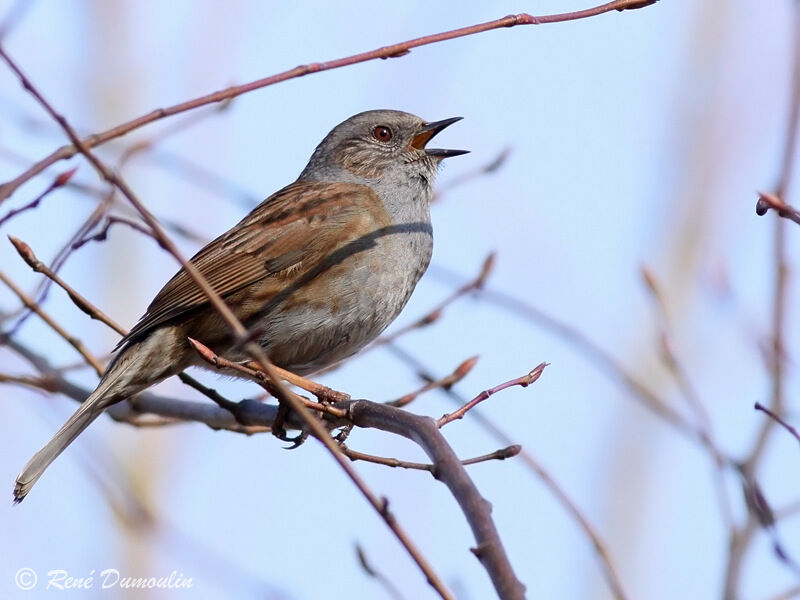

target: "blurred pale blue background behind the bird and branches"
[0,0,800,600]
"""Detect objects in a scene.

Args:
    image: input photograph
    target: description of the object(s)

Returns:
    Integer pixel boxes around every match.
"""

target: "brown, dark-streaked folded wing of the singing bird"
[117,181,390,348]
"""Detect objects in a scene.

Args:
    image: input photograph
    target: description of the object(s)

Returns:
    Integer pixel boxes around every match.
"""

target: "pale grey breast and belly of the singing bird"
[250,182,433,374]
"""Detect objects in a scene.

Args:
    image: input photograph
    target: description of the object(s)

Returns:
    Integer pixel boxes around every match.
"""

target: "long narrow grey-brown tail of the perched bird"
[14,351,144,504]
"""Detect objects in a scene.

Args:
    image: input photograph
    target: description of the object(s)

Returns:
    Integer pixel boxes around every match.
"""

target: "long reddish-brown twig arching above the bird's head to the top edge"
[0,0,657,203]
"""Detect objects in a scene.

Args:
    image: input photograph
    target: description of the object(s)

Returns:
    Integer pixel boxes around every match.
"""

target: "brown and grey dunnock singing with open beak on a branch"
[14,110,466,502]
